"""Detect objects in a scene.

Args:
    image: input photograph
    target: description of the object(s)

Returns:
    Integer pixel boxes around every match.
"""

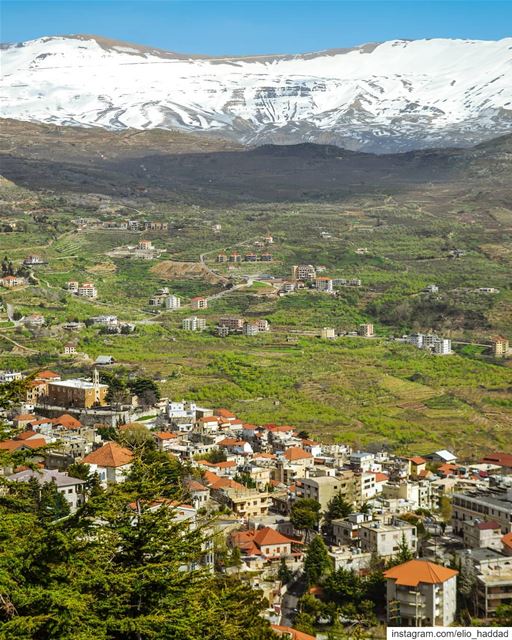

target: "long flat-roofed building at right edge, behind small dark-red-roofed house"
[452,489,512,536]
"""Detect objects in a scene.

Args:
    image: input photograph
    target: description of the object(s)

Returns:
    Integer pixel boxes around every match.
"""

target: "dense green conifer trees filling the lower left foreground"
[0,451,273,640]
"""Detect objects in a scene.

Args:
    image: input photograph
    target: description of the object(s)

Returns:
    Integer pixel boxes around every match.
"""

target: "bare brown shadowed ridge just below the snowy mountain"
[0,121,512,204]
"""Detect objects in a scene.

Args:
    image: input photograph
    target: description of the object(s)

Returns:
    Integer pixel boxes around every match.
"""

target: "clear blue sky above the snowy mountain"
[0,0,512,55]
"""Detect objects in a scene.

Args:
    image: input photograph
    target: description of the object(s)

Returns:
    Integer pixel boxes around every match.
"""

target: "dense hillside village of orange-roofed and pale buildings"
[0,369,512,640]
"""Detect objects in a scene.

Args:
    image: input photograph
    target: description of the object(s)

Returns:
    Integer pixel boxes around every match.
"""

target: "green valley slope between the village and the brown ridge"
[0,178,512,455]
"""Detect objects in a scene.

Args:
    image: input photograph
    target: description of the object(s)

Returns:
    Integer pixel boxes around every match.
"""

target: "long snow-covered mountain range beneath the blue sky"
[0,36,512,152]
